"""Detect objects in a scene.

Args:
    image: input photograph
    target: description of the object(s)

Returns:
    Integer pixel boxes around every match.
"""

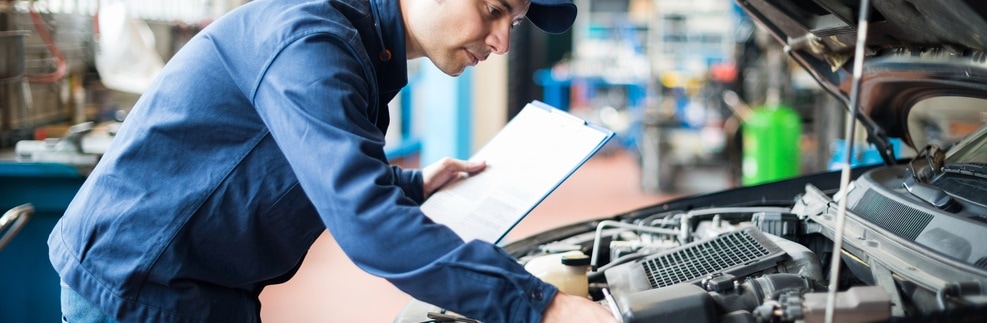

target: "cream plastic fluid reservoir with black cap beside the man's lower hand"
[524,250,590,298]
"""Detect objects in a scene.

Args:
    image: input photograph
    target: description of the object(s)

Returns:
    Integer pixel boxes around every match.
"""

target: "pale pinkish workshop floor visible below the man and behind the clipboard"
[261,149,700,322]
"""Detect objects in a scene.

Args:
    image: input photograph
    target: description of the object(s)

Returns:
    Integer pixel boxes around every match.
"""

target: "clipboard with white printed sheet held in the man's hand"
[421,100,614,244]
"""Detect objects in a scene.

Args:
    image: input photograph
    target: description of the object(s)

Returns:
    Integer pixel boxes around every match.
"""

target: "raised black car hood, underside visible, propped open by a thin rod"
[737,0,987,156]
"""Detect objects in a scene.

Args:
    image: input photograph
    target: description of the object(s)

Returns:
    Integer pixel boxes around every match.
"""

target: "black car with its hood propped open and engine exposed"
[395,0,987,323]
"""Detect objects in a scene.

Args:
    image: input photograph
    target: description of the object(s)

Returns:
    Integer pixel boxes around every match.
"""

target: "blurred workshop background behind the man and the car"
[0,0,920,322]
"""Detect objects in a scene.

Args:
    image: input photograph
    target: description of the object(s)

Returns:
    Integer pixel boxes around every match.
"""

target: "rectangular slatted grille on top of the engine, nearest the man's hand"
[642,230,777,288]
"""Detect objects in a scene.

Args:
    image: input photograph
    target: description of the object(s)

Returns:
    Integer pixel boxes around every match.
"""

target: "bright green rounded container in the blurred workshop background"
[741,104,802,185]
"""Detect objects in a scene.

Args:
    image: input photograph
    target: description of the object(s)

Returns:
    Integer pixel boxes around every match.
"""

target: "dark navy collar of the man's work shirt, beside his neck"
[370,0,408,92]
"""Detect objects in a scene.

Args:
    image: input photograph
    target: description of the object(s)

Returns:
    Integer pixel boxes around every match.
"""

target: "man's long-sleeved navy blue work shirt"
[48,0,557,322]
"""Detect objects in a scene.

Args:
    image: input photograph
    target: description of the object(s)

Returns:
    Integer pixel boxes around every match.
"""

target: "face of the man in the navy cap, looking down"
[403,0,531,76]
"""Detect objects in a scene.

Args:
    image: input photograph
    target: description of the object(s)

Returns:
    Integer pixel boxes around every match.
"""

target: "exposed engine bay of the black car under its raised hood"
[498,160,987,322]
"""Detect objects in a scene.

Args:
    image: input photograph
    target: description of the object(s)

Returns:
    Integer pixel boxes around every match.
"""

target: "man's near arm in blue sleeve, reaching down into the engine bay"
[253,34,557,322]
